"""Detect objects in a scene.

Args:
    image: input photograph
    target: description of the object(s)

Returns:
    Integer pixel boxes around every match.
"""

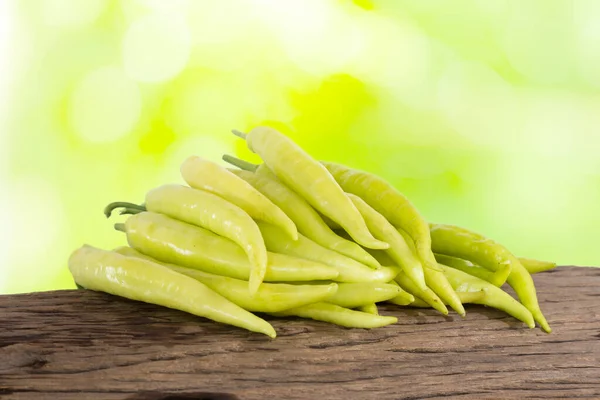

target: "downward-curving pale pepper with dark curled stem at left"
[104,185,267,294]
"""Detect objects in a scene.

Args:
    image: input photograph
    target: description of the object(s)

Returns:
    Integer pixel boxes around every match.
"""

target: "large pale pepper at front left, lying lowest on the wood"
[69,245,276,338]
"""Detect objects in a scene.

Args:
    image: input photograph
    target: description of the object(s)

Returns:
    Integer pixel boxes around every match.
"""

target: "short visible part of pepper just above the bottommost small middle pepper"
[324,283,400,308]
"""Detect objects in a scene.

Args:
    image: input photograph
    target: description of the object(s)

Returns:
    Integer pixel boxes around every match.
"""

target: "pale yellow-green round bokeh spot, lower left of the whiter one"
[68,67,142,143]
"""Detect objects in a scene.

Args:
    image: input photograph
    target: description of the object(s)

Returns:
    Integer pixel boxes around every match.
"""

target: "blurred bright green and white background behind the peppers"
[0,0,600,293]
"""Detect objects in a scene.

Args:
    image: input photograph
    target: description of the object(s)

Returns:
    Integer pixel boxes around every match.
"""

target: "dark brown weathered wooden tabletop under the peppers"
[0,267,600,400]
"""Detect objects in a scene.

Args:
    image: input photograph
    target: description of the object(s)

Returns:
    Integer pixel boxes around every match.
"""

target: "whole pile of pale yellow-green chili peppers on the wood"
[69,126,556,338]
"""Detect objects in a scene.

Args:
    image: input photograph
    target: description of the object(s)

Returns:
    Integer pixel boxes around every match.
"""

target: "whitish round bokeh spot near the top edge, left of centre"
[122,12,191,82]
